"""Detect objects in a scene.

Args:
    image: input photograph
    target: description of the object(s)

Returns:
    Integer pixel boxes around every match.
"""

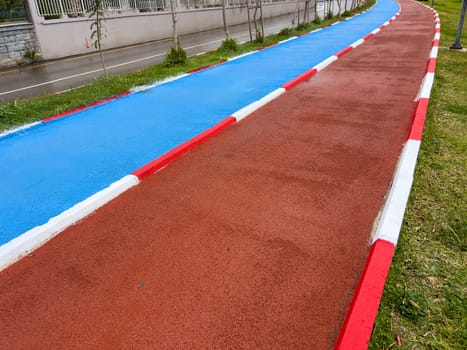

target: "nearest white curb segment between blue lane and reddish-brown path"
[0,175,139,271]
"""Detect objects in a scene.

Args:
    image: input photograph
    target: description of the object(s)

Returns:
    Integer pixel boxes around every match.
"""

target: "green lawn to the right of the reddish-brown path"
[369,0,467,350]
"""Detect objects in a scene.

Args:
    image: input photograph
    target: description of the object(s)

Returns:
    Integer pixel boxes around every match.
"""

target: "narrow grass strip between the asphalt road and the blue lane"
[0,0,374,131]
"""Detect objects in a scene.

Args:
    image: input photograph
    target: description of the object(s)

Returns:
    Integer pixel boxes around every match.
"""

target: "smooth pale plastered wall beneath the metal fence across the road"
[29,0,296,59]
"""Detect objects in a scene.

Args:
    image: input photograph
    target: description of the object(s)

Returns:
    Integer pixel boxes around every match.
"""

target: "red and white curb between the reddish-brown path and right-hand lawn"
[335,4,440,350]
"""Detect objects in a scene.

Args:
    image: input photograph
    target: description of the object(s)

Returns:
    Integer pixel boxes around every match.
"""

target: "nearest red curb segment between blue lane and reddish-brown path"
[132,117,237,180]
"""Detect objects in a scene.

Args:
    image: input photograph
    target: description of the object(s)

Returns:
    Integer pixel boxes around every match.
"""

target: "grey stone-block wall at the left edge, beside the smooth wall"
[0,22,37,67]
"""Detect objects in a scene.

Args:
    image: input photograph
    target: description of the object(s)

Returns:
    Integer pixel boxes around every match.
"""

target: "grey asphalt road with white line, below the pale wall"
[0,14,300,101]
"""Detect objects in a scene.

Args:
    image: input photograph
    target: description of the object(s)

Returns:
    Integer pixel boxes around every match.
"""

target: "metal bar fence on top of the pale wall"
[36,0,290,19]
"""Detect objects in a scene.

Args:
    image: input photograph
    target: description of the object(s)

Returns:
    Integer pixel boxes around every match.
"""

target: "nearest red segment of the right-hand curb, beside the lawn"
[334,240,395,350]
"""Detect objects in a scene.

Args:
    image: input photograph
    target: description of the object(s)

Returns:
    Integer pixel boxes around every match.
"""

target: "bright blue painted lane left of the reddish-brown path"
[0,0,399,245]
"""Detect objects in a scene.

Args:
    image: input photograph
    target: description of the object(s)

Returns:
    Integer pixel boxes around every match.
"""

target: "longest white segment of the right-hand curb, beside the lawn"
[371,140,420,245]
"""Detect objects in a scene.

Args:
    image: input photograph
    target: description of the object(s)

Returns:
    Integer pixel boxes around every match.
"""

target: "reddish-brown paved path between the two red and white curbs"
[0,0,433,349]
